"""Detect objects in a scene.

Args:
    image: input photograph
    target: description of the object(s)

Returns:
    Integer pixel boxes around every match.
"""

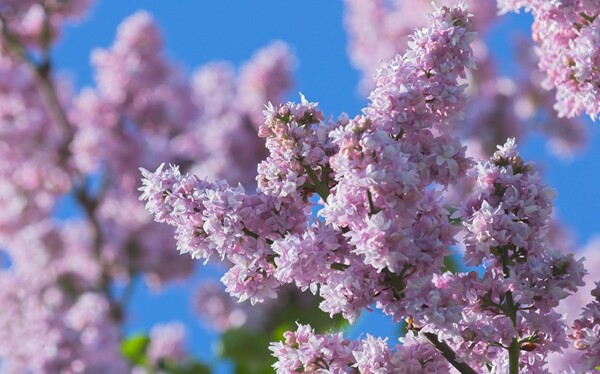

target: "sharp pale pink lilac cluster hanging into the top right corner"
[498,0,600,119]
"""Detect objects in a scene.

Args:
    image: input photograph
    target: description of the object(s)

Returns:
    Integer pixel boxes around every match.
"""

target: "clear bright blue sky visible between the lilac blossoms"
[54,0,600,371]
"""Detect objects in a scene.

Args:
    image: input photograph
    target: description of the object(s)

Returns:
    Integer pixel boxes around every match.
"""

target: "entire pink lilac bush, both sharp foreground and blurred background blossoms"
[0,0,600,374]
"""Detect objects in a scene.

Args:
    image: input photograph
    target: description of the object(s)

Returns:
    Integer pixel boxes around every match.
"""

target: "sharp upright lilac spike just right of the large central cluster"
[447,139,585,370]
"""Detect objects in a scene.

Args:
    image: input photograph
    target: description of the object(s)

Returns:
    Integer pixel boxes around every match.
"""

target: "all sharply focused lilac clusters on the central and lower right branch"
[141,5,596,373]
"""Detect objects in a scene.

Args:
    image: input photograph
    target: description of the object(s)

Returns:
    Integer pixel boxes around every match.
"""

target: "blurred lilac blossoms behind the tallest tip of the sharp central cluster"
[345,0,585,158]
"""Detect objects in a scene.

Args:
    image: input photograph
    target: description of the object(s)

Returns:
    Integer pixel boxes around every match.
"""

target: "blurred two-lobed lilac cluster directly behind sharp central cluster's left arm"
[170,42,294,188]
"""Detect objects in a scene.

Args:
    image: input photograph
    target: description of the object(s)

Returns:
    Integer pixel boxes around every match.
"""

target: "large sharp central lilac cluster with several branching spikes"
[141,3,474,320]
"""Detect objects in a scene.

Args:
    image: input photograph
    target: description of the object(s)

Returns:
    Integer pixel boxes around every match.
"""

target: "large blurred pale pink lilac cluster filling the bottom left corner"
[0,222,127,373]
